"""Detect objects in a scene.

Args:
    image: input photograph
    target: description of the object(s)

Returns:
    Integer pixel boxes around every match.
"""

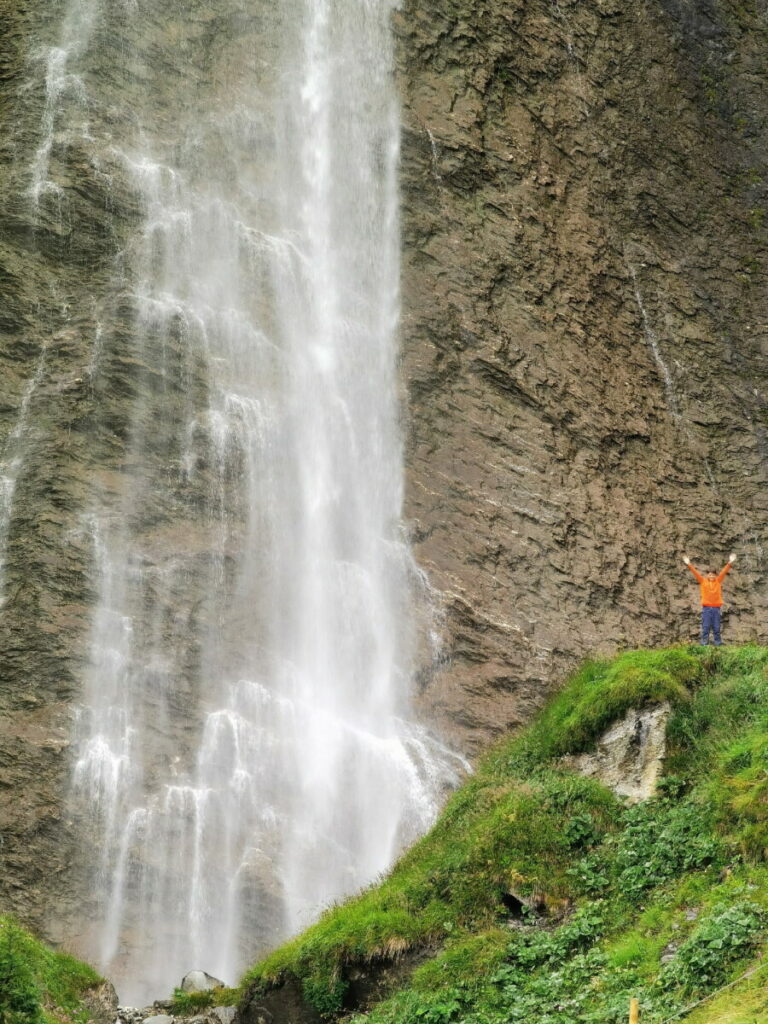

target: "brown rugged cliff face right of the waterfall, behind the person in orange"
[396,0,768,749]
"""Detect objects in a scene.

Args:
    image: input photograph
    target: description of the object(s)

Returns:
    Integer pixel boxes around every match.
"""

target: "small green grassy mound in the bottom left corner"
[0,916,102,1024]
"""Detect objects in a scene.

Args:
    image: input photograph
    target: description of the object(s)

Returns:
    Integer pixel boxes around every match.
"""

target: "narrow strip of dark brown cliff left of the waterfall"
[0,2,111,927]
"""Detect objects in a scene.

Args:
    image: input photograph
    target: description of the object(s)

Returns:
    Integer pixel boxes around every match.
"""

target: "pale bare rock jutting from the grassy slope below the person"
[562,701,671,804]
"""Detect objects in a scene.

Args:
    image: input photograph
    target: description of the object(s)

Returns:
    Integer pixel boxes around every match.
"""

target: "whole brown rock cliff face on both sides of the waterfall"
[0,0,768,954]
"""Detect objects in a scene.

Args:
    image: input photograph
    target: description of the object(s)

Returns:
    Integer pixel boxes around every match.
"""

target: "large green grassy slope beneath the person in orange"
[244,647,768,1024]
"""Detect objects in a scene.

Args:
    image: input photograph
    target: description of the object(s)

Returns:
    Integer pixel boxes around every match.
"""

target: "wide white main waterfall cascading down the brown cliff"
[31,0,462,1000]
